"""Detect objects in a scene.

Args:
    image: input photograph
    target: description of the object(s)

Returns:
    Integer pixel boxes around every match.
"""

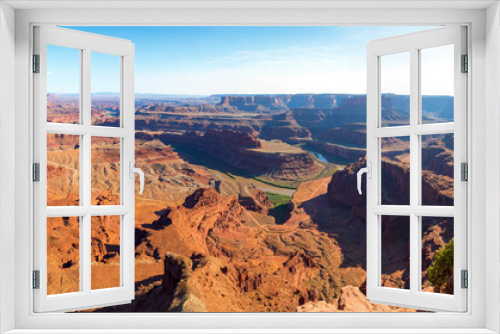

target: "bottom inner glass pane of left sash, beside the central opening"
[91,216,121,290]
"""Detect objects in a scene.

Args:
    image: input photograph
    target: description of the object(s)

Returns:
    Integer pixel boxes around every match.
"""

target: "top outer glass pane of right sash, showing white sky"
[420,45,455,124]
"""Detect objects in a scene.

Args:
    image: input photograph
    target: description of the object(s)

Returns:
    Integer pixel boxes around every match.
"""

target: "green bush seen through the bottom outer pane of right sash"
[427,239,454,293]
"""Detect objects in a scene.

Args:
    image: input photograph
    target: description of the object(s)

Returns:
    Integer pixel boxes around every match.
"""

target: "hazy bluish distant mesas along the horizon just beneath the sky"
[48,92,453,125]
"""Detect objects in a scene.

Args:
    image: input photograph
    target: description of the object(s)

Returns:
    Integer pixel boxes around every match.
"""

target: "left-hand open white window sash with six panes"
[33,26,135,312]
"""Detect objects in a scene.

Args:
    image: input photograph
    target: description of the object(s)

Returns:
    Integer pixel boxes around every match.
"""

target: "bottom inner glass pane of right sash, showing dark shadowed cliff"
[381,216,410,289]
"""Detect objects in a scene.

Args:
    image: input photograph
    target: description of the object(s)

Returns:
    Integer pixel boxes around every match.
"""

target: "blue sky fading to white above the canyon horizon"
[47,26,453,95]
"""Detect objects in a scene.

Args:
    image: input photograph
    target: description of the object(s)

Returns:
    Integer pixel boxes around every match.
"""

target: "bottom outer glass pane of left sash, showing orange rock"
[47,217,80,295]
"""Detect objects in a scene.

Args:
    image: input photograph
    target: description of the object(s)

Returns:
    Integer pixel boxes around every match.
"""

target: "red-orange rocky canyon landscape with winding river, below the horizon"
[47,94,453,312]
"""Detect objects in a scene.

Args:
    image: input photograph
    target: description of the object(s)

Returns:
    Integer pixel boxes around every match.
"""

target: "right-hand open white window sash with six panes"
[366,26,468,312]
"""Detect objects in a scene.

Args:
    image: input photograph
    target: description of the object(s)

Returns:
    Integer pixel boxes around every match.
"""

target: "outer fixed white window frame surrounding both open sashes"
[0,1,500,333]
